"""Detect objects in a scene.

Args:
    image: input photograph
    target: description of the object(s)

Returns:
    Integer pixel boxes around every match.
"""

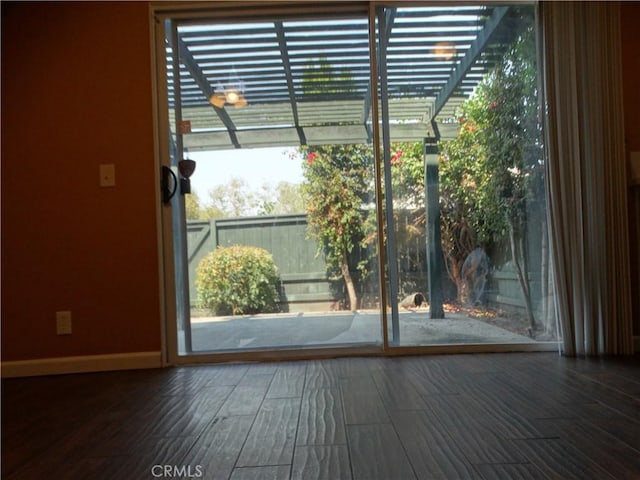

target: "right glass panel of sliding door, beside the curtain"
[376,4,558,346]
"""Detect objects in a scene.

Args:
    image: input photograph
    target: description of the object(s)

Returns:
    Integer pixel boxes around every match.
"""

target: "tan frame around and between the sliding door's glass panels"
[149,0,558,365]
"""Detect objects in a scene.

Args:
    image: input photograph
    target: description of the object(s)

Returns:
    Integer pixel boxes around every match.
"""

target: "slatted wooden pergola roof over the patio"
[167,6,523,151]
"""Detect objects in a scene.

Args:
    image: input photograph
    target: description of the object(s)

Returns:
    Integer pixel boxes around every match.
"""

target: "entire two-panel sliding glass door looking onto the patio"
[157,2,557,358]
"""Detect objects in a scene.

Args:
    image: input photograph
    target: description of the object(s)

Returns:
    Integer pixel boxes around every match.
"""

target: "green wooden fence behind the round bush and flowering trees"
[187,214,539,312]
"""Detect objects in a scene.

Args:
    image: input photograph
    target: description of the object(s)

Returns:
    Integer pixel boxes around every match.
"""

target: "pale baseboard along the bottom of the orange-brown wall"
[0,352,162,378]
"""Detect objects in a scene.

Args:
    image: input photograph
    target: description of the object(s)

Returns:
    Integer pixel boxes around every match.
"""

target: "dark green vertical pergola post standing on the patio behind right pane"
[423,138,444,318]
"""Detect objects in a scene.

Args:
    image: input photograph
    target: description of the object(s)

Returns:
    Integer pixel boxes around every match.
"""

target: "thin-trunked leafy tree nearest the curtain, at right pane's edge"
[483,28,542,330]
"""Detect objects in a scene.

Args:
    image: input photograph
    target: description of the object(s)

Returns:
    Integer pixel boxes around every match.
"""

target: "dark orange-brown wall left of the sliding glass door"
[2,2,160,361]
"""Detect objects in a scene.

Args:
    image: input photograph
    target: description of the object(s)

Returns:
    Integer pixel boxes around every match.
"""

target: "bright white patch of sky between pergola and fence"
[188,147,303,199]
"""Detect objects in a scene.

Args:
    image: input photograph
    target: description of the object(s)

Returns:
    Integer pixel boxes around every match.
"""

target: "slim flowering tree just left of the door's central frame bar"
[300,144,373,310]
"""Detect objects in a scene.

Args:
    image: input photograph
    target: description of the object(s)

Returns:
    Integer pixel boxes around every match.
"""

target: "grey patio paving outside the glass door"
[192,310,535,351]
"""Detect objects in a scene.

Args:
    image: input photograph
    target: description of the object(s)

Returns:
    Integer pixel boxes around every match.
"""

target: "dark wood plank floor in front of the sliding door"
[2,353,640,480]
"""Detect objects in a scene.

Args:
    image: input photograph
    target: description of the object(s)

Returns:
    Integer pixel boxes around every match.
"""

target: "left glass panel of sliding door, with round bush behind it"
[170,14,382,354]
